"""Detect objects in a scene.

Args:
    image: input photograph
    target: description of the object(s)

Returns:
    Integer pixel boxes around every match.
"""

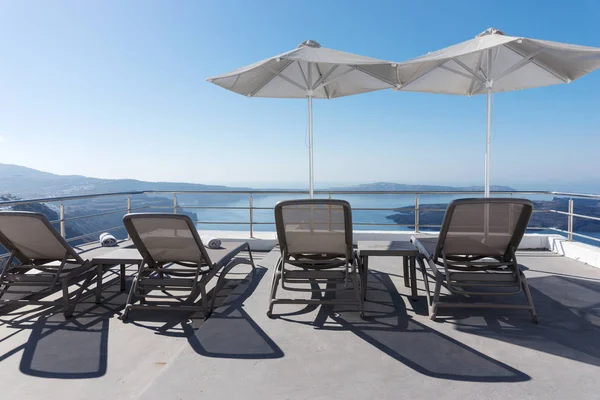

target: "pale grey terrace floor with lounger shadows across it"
[0,251,600,400]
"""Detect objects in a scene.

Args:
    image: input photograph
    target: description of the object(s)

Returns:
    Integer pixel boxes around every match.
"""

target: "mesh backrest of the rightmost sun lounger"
[436,198,533,257]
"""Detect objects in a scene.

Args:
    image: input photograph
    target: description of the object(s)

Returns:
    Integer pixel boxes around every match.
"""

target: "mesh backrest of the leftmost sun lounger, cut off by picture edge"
[0,211,83,263]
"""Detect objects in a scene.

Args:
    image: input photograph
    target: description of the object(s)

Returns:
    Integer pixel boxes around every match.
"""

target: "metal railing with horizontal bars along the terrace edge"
[0,190,600,242]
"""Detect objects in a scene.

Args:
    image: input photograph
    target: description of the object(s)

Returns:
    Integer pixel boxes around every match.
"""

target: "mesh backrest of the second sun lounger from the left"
[123,213,211,265]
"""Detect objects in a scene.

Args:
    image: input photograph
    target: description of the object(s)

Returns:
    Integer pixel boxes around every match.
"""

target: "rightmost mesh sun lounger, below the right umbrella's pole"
[413,198,538,323]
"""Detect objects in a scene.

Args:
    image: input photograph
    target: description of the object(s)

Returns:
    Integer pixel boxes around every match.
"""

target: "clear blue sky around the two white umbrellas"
[0,0,600,190]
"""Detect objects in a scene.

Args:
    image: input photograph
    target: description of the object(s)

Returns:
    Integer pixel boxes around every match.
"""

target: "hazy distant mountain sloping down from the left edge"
[0,163,247,198]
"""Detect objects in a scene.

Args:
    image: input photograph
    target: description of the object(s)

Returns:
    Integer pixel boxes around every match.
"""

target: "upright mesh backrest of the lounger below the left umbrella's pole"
[275,199,352,257]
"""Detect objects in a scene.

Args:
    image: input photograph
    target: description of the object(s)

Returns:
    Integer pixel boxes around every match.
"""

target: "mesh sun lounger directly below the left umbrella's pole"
[267,199,363,316]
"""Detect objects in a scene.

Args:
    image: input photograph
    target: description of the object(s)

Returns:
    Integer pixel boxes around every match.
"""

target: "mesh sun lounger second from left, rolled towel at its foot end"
[122,213,254,321]
